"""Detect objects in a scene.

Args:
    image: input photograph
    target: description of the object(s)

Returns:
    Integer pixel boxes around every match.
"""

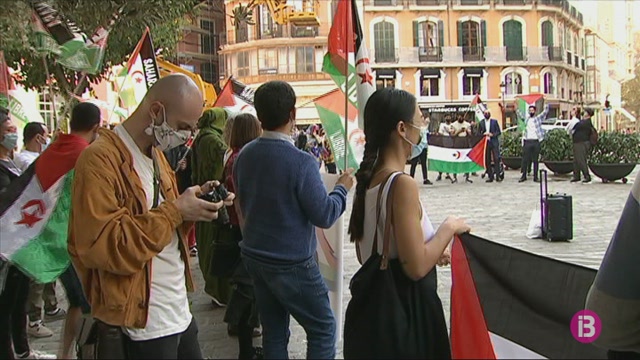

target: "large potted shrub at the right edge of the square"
[589,131,640,183]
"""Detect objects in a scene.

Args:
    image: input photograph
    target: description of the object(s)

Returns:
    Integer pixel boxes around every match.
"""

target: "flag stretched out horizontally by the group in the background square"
[427,135,488,174]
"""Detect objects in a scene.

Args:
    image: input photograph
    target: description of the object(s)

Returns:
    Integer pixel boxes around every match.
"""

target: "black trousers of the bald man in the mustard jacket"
[125,319,202,359]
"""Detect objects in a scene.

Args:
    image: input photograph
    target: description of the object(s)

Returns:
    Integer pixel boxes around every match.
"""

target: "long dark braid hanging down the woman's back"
[349,139,379,242]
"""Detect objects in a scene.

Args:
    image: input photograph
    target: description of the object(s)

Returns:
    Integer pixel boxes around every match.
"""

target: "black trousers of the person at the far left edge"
[0,266,30,359]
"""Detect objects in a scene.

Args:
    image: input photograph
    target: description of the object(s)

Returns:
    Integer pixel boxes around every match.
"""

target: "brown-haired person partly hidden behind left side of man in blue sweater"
[223,114,262,359]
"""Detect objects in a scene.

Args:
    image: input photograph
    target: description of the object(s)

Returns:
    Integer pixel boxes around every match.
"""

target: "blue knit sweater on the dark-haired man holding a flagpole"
[234,132,347,265]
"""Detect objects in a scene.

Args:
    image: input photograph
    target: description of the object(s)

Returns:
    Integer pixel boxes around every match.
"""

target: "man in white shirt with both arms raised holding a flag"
[517,104,549,182]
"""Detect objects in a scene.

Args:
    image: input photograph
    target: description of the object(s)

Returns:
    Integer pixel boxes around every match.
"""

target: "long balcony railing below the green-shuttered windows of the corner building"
[384,46,564,64]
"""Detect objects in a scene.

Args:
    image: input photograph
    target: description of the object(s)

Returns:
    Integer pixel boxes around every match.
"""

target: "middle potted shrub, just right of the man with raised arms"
[540,129,573,175]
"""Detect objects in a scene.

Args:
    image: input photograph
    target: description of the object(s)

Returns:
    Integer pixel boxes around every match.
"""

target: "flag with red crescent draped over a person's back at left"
[0,135,86,283]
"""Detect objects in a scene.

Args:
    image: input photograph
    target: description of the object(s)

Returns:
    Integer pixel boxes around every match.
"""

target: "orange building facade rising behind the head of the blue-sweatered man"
[220,0,338,125]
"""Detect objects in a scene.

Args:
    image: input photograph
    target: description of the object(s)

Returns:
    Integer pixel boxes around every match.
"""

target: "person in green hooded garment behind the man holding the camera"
[191,108,231,305]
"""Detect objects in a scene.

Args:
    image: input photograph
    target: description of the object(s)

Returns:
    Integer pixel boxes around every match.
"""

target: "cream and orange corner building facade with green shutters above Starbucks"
[364,0,586,127]
